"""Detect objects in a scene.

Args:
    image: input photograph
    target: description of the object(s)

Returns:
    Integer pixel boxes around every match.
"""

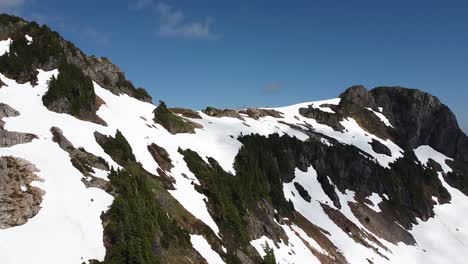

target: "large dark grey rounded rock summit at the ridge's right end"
[340,86,468,162]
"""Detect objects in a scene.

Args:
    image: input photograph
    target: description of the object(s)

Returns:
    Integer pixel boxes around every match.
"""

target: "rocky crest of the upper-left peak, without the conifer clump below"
[0,14,152,102]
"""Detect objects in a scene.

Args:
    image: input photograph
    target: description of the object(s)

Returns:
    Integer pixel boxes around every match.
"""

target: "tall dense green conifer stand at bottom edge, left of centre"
[104,163,191,264]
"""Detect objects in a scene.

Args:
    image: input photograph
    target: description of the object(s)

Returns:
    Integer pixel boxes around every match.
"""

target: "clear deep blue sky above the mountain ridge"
[0,0,468,131]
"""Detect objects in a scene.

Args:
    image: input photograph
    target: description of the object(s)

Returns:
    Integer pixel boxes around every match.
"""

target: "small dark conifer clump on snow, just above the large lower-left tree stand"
[96,130,135,166]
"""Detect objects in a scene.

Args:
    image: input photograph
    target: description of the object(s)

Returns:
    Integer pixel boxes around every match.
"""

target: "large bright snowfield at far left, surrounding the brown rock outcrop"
[0,71,113,264]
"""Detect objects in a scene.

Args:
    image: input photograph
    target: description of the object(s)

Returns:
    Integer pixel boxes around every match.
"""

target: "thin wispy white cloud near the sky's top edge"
[129,0,219,39]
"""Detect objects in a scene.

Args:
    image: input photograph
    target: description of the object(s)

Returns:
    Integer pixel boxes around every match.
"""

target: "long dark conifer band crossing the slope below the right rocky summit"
[235,134,452,224]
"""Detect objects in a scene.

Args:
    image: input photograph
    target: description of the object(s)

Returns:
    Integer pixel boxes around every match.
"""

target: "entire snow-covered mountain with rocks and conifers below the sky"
[0,15,468,264]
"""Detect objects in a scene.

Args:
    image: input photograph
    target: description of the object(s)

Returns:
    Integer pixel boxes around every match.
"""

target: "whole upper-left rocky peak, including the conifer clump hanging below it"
[0,14,151,121]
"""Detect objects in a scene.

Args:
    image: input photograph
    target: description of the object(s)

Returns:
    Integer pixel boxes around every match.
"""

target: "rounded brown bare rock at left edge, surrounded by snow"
[0,156,44,229]
